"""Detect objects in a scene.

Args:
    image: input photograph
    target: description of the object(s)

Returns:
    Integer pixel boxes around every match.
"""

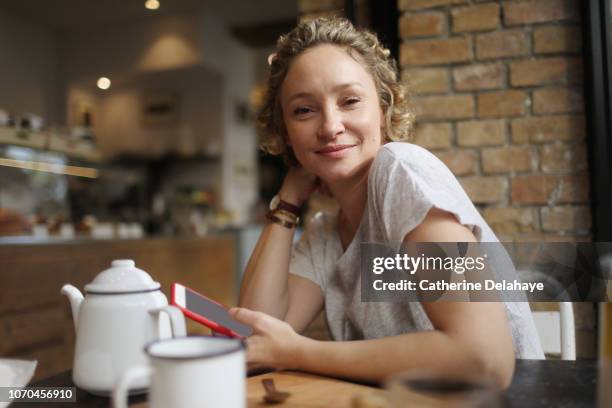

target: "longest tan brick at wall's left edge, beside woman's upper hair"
[400,38,472,66]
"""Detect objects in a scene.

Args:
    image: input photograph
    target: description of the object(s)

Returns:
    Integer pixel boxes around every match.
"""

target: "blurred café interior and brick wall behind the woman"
[0,0,612,375]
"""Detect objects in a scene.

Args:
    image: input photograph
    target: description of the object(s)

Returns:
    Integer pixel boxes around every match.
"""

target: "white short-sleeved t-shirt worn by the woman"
[289,143,544,359]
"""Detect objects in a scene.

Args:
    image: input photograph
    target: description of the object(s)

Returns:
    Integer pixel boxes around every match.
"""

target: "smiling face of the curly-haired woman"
[280,44,382,182]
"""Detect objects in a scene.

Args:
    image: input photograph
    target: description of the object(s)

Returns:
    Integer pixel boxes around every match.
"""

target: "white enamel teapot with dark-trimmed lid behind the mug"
[61,259,186,396]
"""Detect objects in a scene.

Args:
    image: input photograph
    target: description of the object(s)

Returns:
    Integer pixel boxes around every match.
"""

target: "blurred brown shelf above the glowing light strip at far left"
[0,126,102,162]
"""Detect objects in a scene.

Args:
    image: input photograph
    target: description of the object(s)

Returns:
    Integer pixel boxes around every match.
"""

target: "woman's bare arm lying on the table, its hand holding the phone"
[234,209,514,387]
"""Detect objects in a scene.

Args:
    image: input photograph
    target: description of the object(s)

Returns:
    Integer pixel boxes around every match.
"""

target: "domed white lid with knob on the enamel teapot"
[85,259,161,294]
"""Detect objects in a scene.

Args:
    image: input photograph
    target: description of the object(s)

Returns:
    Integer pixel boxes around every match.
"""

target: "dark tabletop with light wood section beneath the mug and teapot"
[11,360,597,408]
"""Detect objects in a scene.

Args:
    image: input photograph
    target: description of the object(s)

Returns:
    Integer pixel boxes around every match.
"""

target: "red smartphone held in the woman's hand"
[170,283,253,339]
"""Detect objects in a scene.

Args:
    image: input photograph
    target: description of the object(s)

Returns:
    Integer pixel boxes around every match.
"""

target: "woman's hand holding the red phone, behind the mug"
[230,307,305,370]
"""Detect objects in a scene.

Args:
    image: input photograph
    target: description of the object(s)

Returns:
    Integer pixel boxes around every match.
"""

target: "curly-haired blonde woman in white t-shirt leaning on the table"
[232,19,543,387]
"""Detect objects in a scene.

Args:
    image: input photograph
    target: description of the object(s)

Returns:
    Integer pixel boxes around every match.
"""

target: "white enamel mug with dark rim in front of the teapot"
[113,336,246,408]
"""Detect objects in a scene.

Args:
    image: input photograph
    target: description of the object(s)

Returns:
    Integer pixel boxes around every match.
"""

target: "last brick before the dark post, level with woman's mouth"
[540,143,588,174]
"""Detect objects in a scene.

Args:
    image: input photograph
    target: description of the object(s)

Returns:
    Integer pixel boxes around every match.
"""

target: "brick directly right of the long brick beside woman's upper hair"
[476,30,529,60]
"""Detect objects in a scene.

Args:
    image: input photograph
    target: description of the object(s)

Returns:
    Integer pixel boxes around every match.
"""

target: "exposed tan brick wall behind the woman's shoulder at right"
[398,0,591,241]
